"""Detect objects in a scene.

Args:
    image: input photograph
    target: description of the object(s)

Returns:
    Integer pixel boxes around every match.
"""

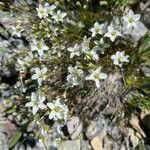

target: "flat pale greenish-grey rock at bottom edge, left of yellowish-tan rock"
[58,140,81,150]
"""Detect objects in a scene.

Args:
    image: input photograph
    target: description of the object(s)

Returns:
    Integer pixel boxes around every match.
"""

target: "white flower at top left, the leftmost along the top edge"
[36,4,48,19]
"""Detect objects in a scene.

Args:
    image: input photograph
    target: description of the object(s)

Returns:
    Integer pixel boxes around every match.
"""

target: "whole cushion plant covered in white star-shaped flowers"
[0,0,147,148]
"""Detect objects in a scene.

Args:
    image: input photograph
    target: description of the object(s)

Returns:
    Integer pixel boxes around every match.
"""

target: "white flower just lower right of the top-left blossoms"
[52,10,67,22]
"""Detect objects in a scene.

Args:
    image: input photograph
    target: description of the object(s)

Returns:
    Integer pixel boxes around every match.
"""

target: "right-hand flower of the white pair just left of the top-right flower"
[104,25,121,42]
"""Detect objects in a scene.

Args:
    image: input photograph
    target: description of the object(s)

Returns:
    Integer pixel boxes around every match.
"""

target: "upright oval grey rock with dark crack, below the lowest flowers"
[67,116,83,139]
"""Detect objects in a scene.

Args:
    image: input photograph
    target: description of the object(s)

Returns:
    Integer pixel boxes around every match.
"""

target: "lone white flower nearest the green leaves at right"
[111,51,129,67]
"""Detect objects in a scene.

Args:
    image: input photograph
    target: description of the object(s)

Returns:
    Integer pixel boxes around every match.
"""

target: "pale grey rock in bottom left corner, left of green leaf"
[0,126,8,150]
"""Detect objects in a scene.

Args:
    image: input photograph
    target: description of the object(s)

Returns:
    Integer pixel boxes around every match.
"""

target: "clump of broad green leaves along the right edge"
[125,34,150,112]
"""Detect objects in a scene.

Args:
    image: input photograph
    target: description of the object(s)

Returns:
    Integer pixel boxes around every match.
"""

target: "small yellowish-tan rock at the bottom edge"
[90,136,102,150]
